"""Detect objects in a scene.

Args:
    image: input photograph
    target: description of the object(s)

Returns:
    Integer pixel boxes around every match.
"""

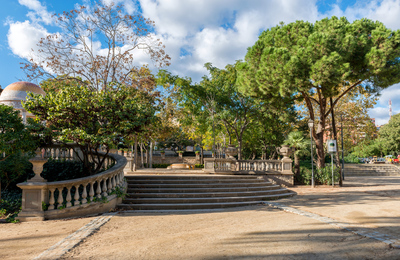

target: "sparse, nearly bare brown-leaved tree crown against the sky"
[23,1,170,90]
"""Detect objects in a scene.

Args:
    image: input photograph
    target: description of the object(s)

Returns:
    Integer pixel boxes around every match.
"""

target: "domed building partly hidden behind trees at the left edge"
[0,81,46,124]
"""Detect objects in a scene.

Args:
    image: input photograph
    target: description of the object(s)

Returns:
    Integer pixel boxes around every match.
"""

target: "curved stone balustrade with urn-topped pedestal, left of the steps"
[18,150,127,221]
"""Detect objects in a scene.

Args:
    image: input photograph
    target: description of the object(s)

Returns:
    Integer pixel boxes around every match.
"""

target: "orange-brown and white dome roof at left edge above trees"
[0,81,46,102]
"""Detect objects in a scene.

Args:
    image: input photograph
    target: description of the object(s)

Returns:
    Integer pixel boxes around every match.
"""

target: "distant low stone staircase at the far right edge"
[344,164,400,176]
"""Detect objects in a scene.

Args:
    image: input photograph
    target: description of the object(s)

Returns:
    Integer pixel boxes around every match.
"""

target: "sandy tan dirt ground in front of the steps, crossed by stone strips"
[0,177,400,259]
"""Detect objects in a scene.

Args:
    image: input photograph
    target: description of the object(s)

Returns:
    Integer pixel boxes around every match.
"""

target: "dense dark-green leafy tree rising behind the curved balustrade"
[23,85,156,174]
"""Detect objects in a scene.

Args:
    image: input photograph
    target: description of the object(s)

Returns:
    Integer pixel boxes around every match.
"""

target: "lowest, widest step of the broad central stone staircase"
[118,192,295,210]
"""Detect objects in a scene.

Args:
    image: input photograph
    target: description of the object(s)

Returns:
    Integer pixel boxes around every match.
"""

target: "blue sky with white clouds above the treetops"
[0,0,400,125]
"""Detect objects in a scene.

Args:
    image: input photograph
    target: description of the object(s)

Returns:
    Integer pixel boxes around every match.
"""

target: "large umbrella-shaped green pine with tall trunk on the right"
[238,17,400,167]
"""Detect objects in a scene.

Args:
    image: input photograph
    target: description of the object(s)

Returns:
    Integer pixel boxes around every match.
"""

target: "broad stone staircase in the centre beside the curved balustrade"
[118,175,295,210]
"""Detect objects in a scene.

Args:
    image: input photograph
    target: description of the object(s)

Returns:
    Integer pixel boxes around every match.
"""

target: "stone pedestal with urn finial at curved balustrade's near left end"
[17,149,49,221]
